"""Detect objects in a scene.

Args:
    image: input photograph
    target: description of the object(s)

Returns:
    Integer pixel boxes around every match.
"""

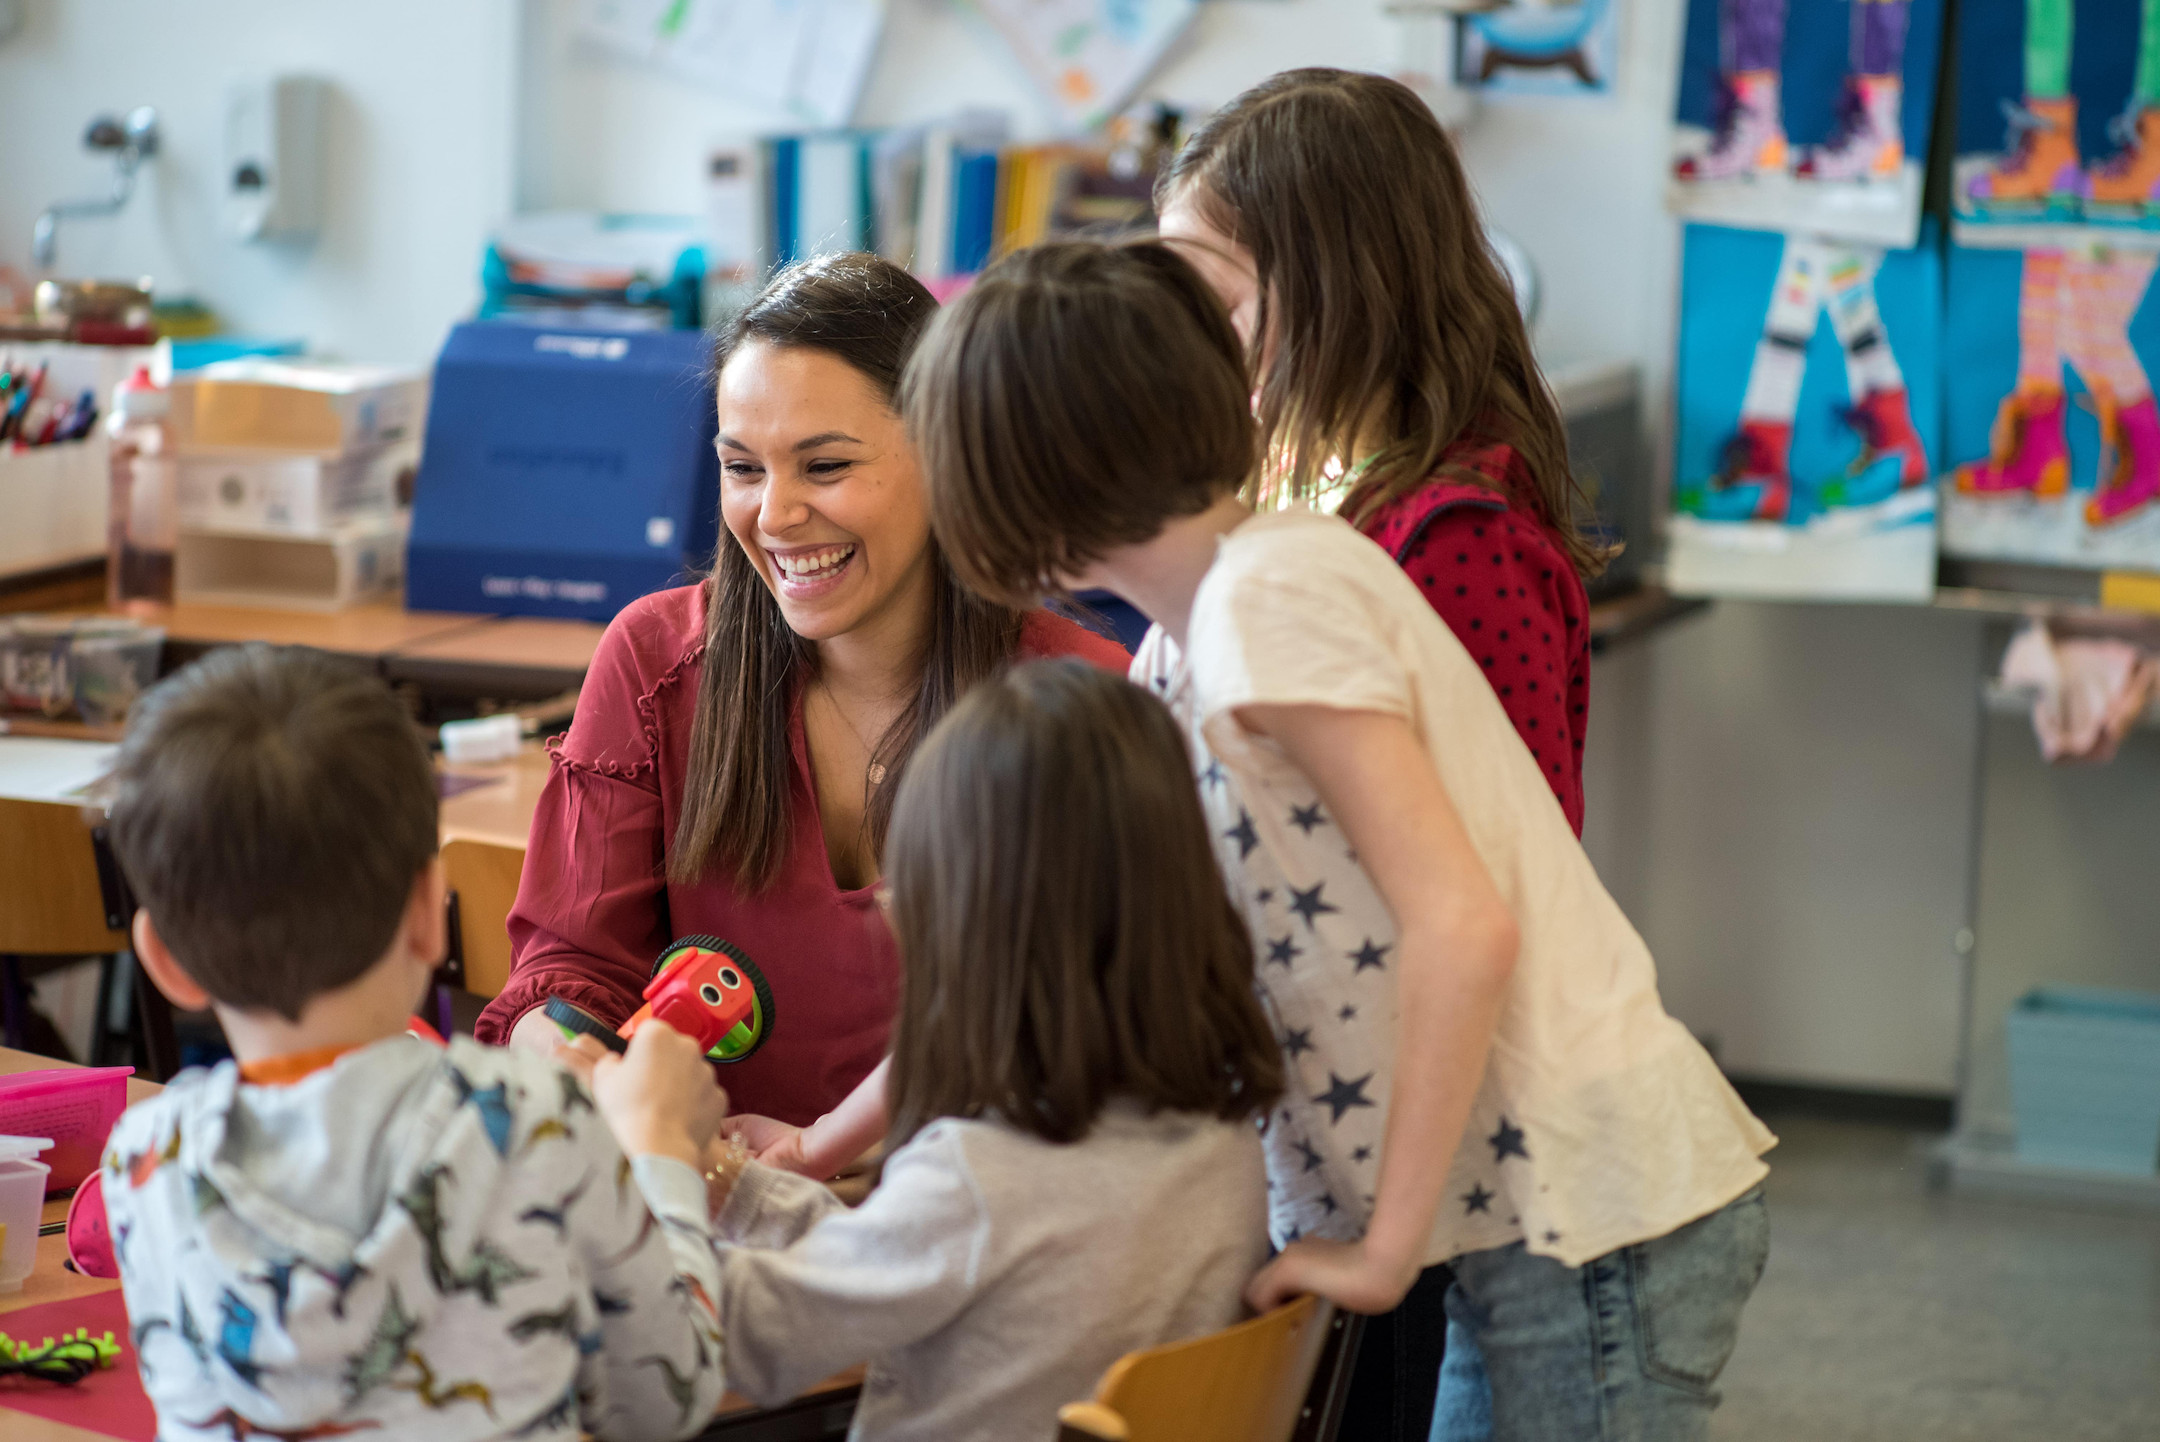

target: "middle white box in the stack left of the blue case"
[179,443,419,535]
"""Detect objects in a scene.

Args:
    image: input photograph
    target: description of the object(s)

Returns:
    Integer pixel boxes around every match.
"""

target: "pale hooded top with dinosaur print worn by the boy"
[104,1038,726,1442]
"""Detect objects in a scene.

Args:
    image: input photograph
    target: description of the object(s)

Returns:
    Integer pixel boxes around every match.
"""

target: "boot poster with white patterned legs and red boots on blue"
[1665,222,1944,600]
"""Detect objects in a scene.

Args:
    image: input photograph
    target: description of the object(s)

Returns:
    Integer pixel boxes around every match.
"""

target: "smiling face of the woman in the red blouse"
[717,341,931,641]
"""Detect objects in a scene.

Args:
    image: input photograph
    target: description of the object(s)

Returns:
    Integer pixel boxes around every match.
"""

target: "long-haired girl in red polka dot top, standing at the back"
[1156,69,1601,835]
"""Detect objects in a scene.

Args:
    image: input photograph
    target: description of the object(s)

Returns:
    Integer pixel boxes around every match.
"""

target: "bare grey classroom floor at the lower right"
[1713,1118,2160,1442]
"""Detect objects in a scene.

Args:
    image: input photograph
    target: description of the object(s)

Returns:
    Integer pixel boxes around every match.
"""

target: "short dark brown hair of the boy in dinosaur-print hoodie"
[112,645,436,1021]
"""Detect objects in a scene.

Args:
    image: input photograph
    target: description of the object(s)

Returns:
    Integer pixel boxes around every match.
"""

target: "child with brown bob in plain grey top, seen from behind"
[578,661,1281,1442]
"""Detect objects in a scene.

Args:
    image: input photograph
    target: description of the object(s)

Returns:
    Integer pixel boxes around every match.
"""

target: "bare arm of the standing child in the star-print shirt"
[1238,706,1516,1312]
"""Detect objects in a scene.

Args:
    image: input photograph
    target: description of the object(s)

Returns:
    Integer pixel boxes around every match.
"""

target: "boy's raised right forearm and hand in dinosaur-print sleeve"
[562,1023,728,1438]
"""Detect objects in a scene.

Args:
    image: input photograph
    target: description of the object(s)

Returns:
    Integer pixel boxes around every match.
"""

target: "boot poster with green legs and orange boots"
[1953,0,2160,250]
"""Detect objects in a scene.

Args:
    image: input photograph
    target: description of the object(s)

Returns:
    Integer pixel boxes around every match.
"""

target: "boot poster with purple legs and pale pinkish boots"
[1665,0,1952,250]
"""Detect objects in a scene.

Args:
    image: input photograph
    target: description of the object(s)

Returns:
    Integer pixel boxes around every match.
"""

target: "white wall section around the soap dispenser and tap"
[0,0,518,361]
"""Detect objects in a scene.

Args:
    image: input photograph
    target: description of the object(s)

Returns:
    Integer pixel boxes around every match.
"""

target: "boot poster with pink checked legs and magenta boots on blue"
[1942,245,2160,570]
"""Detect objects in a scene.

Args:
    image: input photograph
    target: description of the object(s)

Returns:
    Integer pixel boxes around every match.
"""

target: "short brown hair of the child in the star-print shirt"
[901,242,1257,604]
